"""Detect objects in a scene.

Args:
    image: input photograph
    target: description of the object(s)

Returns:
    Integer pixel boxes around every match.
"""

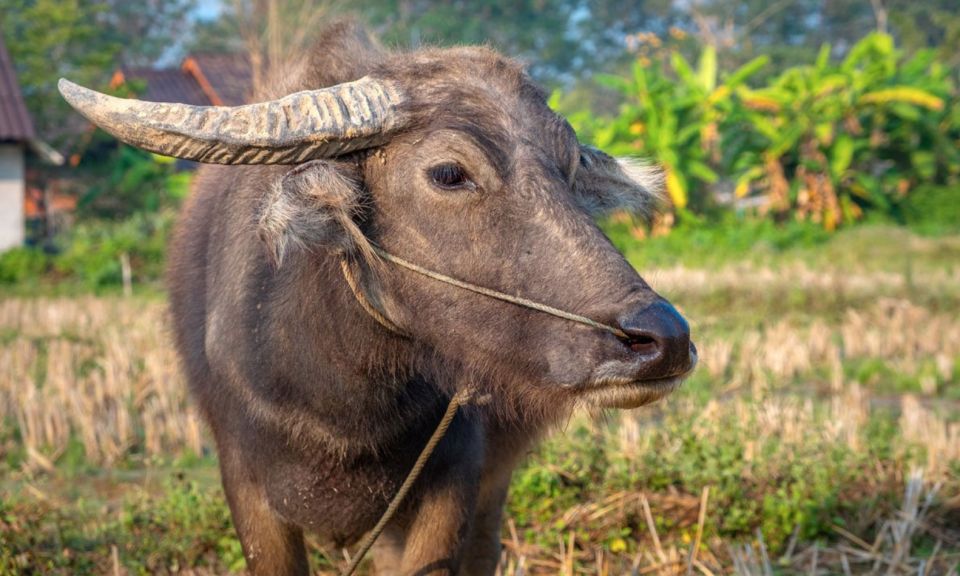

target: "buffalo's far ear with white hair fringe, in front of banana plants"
[573,146,663,219]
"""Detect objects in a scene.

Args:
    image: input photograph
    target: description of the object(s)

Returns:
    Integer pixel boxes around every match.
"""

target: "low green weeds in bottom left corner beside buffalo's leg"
[0,478,238,575]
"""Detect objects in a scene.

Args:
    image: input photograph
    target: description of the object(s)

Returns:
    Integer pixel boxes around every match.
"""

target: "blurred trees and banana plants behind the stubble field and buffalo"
[0,0,960,289]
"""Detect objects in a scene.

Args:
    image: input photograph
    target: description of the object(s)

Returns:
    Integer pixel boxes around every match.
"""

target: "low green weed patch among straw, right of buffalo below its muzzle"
[508,396,920,554]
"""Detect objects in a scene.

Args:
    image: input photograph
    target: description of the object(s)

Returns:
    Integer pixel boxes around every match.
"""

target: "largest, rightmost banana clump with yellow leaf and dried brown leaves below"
[734,34,948,229]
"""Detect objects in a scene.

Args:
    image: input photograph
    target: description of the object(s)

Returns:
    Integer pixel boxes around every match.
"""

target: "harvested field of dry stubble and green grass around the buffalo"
[0,227,960,576]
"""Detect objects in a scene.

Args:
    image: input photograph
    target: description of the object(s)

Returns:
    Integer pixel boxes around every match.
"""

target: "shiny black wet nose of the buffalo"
[619,300,692,378]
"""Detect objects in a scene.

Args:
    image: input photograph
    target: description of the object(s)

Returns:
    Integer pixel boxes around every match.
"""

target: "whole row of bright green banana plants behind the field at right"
[564,34,960,230]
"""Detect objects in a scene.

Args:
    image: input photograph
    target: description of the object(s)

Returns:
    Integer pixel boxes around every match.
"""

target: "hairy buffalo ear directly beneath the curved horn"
[259,160,369,266]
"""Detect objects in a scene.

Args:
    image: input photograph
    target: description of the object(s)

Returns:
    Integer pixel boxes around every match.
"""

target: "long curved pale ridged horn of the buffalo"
[58,77,404,164]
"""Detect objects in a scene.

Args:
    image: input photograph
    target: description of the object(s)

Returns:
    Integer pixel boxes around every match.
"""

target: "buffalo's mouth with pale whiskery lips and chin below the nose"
[577,342,698,409]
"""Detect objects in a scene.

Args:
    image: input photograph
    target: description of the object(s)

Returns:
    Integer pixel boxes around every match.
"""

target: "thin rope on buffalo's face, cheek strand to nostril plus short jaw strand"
[340,243,629,340]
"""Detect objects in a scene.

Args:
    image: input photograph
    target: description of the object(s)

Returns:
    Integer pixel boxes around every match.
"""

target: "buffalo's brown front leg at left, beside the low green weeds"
[220,445,310,576]
